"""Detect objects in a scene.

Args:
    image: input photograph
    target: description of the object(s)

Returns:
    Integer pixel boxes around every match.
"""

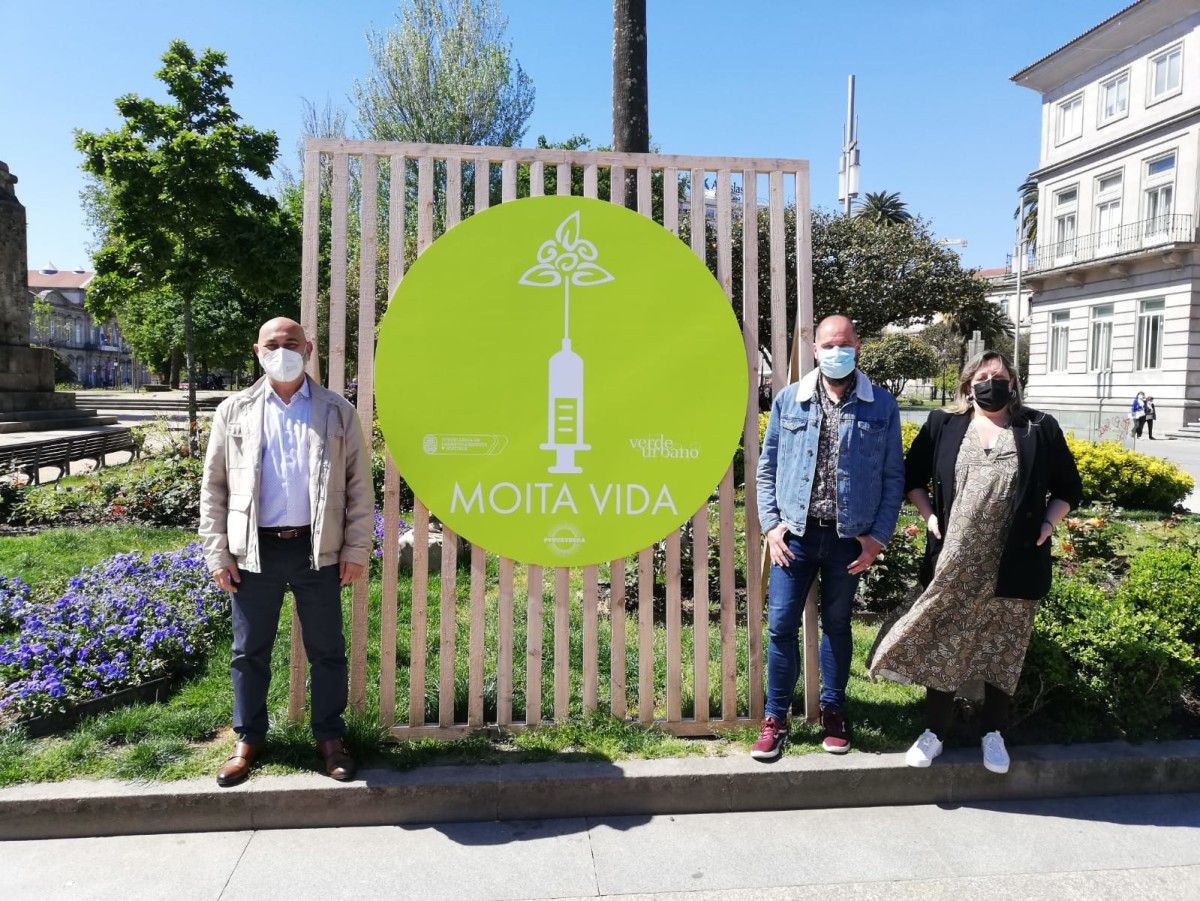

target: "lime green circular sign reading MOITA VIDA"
[376,197,748,566]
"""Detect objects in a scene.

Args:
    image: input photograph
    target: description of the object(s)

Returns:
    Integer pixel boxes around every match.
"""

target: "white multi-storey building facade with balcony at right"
[1013,0,1200,434]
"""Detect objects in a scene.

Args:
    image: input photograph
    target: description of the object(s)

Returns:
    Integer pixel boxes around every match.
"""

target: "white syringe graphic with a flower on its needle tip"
[520,211,612,473]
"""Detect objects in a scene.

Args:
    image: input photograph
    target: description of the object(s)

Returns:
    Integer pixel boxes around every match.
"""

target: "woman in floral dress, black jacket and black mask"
[869,352,1081,773]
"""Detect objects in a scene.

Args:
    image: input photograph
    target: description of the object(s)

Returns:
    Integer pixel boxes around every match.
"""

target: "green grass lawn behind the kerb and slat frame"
[0,527,920,785]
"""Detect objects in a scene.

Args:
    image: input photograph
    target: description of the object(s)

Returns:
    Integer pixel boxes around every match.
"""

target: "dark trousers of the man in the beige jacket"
[229,535,347,743]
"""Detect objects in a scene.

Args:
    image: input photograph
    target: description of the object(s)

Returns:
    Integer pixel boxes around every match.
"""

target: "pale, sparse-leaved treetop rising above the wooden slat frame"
[354,0,534,146]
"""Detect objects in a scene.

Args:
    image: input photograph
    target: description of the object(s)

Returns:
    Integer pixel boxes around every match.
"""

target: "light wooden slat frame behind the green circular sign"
[289,139,816,738]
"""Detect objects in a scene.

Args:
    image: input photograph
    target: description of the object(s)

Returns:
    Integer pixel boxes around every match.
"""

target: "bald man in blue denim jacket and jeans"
[750,316,904,761]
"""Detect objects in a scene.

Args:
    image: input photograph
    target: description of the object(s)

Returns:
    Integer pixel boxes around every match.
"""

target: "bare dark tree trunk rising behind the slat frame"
[612,0,650,210]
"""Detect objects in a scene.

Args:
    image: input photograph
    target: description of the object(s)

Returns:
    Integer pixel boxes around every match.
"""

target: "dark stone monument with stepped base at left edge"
[0,162,114,433]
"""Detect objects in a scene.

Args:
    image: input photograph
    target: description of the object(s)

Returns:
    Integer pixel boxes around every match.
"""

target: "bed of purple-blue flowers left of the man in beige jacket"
[0,545,229,719]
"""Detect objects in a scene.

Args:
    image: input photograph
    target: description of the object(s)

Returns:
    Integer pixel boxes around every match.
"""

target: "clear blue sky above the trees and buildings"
[0,0,1126,268]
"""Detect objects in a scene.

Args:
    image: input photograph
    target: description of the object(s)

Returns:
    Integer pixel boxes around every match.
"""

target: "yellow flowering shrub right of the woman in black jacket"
[1067,436,1195,511]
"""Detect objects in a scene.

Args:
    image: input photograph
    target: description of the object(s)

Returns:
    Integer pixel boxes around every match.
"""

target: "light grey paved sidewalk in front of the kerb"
[0,794,1200,901]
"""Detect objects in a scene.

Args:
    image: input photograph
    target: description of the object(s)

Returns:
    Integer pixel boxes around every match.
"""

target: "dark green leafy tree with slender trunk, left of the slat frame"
[76,41,300,450]
